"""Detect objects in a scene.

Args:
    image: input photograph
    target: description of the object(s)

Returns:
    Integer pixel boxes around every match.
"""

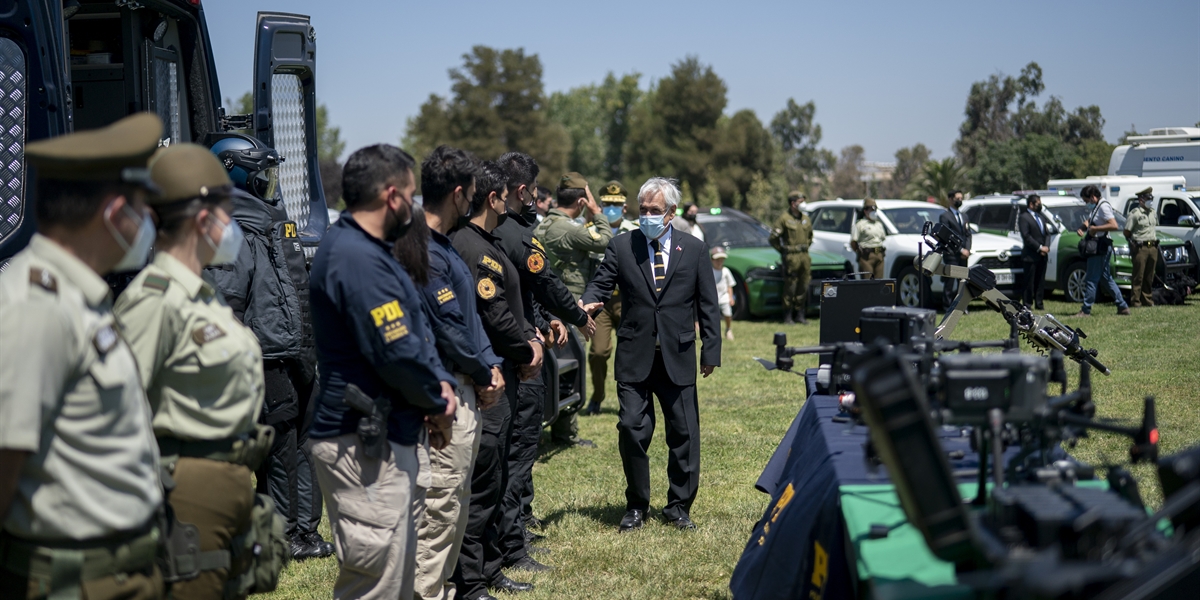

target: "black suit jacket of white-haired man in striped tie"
[583,225,721,385]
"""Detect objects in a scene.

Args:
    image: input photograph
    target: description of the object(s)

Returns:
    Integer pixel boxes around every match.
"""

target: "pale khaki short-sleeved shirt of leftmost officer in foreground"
[0,234,162,542]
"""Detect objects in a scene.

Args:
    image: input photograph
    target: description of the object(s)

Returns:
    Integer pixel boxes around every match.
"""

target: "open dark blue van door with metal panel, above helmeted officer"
[253,12,329,252]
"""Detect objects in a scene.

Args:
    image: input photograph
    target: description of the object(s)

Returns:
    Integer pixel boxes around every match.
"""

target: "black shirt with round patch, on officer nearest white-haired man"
[494,210,588,328]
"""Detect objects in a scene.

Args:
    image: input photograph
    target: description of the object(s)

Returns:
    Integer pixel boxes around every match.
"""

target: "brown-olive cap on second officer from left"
[146,144,233,204]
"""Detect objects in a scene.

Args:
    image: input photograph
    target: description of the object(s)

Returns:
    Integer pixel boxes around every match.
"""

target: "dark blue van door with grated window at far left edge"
[0,0,71,262]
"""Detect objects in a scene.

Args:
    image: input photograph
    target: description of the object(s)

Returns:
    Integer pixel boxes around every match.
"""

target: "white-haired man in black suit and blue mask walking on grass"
[582,178,721,532]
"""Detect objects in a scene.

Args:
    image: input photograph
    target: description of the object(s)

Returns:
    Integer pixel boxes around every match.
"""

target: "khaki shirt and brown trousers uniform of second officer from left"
[115,253,264,599]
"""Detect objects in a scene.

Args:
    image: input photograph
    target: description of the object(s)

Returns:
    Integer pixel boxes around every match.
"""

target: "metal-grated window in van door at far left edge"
[0,37,26,248]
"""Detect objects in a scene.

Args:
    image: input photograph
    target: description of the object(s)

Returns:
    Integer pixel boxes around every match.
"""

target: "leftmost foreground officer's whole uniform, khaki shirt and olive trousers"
[0,234,163,599]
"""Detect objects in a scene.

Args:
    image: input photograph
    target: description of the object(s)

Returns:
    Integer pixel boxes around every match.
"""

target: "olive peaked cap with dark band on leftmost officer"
[25,113,162,188]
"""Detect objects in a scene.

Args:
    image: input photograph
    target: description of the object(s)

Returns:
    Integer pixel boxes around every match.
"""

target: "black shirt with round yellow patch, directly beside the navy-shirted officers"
[450,223,536,365]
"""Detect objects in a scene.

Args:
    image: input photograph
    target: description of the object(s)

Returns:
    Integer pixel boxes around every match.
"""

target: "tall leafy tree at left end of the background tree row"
[404,46,571,182]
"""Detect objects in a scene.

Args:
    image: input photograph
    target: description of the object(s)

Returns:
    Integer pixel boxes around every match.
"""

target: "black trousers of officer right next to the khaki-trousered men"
[451,362,517,600]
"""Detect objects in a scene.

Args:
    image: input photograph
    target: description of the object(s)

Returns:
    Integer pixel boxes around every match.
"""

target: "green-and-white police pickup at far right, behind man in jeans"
[962,191,1198,302]
